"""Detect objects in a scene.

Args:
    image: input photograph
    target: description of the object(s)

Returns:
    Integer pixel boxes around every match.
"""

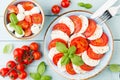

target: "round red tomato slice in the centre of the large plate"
[70,37,88,54]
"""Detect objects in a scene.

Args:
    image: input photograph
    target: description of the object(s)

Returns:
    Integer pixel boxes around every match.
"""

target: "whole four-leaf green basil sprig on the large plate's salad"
[56,42,84,66]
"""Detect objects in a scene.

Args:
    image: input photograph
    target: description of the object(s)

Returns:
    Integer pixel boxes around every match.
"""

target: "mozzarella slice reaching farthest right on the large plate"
[90,44,109,54]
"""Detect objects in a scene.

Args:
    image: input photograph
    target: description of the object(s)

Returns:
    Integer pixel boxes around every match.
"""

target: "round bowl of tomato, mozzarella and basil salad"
[4,0,44,39]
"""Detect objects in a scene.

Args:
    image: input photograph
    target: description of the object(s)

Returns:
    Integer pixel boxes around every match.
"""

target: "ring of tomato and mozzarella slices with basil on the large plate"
[48,15,109,75]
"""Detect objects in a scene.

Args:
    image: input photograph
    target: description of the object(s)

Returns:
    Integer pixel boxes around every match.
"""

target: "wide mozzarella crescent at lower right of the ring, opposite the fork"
[82,51,100,66]
